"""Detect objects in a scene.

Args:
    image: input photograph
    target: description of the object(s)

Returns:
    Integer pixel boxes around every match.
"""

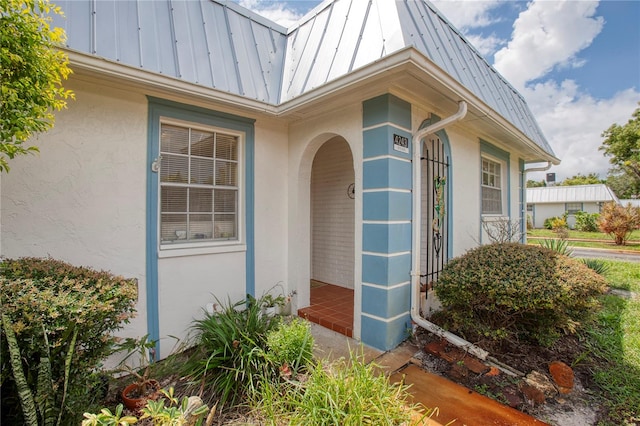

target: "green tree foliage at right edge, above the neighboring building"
[599,108,640,178]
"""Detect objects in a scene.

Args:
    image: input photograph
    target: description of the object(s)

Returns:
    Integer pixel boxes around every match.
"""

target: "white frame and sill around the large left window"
[156,117,246,253]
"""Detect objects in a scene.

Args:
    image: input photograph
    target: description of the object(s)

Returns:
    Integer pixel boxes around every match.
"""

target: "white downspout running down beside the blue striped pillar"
[411,101,489,360]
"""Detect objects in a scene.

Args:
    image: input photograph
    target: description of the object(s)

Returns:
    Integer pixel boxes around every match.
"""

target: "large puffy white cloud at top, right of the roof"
[494,0,604,90]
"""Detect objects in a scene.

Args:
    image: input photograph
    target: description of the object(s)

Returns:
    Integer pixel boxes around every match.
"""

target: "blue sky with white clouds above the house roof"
[236,0,640,180]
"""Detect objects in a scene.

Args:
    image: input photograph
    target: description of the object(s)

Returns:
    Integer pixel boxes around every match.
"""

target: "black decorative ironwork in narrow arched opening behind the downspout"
[420,135,449,289]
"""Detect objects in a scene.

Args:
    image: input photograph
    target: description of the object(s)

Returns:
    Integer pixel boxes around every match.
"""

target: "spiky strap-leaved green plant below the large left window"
[184,296,280,405]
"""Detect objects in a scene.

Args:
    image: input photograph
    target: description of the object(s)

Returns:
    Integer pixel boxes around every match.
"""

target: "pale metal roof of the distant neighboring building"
[527,184,620,204]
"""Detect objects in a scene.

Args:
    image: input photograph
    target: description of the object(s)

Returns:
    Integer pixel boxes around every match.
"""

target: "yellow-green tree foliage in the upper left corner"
[0,0,73,172]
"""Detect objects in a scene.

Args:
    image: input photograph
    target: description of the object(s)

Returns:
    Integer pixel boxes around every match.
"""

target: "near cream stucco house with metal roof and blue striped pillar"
[0,0,559,356]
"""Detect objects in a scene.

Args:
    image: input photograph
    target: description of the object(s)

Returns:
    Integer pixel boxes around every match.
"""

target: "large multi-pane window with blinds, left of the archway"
[160,123,239,244]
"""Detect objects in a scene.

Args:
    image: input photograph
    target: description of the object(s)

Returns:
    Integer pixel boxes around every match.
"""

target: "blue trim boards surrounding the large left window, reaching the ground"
[146,96,255,356]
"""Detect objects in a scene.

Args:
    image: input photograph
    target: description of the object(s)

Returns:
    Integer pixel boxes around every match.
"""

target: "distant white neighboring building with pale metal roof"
[527,184,620,228]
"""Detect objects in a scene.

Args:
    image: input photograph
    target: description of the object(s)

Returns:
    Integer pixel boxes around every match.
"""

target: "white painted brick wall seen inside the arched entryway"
[311,138,355,288]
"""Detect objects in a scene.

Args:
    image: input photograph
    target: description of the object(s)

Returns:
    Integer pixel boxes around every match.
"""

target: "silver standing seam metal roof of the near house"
[54,0,554,155]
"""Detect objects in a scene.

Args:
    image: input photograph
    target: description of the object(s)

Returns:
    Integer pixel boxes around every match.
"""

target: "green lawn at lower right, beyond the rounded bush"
[584,260,640,425]
